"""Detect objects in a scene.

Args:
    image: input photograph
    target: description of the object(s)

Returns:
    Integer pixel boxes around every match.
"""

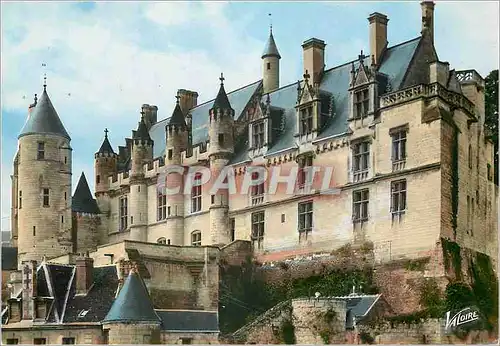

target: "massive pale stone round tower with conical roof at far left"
[18,83,72,264]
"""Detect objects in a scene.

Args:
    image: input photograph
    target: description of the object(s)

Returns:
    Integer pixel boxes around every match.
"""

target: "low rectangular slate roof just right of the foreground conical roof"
[156,310,219,333]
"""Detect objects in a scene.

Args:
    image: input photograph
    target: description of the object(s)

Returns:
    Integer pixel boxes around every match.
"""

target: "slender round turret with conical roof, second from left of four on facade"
[129,111,153,242]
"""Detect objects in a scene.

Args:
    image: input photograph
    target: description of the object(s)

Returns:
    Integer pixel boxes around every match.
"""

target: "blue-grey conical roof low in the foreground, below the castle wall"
[102,269,161,323]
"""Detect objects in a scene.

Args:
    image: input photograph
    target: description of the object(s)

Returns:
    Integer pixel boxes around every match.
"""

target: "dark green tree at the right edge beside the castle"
[484,70,498,185]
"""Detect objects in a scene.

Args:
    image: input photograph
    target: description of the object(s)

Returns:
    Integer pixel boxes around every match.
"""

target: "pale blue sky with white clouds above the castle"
[1,1,498,230]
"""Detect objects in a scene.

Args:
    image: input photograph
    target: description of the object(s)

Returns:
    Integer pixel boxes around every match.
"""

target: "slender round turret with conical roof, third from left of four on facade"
[164,96,188,245]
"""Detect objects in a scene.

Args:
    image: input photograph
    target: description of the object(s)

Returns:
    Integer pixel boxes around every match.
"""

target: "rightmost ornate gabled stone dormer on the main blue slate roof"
[349,51,378,128]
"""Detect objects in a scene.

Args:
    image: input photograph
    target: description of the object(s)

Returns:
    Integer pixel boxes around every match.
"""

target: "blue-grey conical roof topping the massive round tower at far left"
[18,88,71,139]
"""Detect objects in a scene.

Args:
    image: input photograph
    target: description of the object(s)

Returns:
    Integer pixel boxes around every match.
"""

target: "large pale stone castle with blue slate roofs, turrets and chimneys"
[4,2,498,343]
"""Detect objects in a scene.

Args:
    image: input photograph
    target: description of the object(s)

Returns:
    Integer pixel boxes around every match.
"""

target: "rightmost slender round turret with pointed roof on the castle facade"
[208,73,234,245]
